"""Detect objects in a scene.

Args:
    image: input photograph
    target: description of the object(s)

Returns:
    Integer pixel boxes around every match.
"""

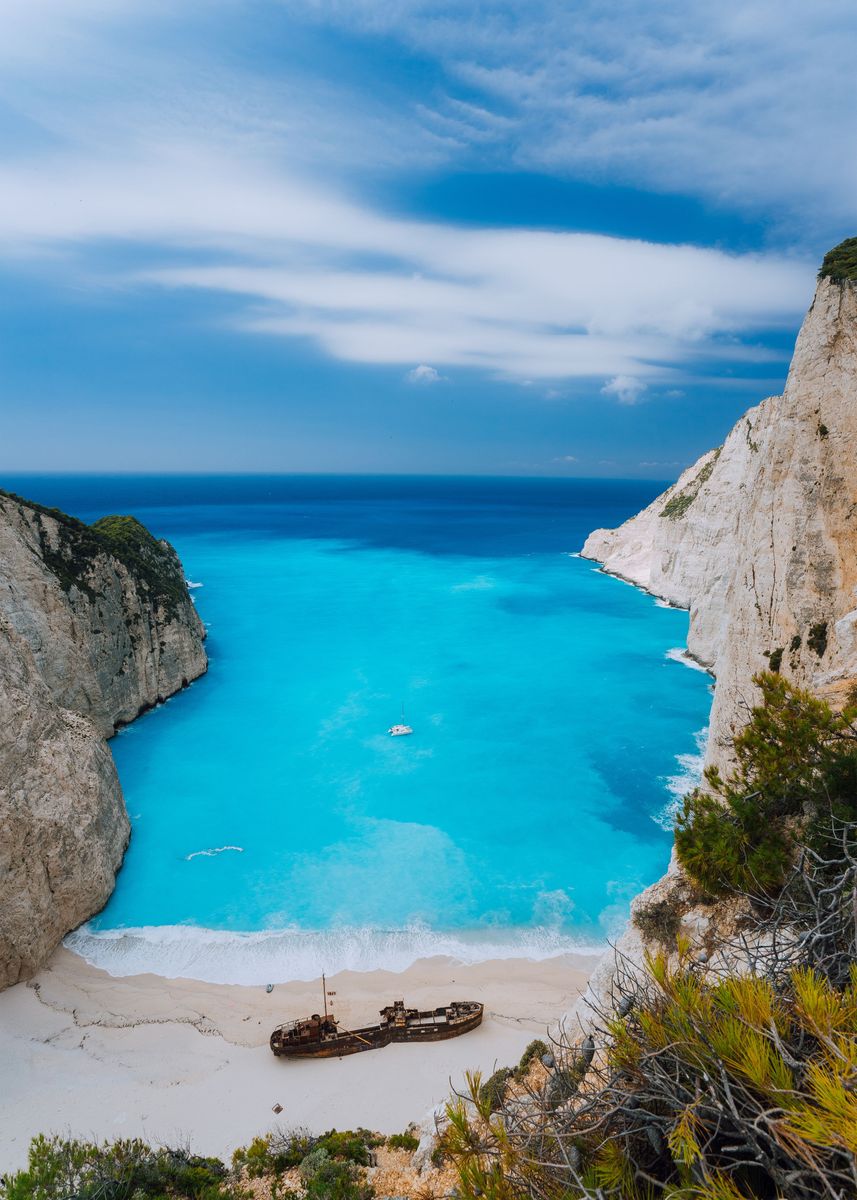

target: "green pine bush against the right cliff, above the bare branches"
[676,672,857,895]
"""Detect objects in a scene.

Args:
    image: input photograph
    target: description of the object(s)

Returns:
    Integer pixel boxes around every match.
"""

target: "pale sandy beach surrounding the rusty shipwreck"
[0,949,595,1170]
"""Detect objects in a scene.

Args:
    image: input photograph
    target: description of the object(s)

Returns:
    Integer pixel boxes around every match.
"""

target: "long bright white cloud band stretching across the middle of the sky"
[0,144,811,384]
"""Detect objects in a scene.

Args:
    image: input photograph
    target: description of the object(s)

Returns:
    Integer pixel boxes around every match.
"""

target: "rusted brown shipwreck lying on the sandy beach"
[271,1000,484,1058]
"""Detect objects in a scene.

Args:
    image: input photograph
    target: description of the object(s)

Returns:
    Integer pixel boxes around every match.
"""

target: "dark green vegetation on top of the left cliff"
[0,490,187,616]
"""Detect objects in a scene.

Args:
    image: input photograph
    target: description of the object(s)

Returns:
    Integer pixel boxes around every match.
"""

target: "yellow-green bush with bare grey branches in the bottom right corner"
[443,955,857,1200]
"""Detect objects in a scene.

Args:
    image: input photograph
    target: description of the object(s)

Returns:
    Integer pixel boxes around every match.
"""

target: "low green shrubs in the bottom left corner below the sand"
[0,1136,245,1200]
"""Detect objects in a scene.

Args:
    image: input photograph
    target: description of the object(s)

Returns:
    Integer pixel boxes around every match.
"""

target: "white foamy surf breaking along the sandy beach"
[64,925,605,985]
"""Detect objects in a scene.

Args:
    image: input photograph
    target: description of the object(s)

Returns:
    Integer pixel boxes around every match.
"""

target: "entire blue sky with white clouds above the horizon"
[0,0,857,479]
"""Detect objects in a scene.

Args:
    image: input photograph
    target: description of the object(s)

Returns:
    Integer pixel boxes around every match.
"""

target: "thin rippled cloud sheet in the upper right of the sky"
[289,0,857,229]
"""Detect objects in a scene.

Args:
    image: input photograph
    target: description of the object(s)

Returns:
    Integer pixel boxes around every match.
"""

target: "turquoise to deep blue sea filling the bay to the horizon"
[4,476,711,983]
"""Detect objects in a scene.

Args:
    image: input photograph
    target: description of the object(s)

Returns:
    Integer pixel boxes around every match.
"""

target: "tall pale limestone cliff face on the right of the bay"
[583,278,857,764]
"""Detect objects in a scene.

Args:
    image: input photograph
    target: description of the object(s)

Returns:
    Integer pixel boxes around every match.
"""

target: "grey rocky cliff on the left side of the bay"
[0,493,206,988]
